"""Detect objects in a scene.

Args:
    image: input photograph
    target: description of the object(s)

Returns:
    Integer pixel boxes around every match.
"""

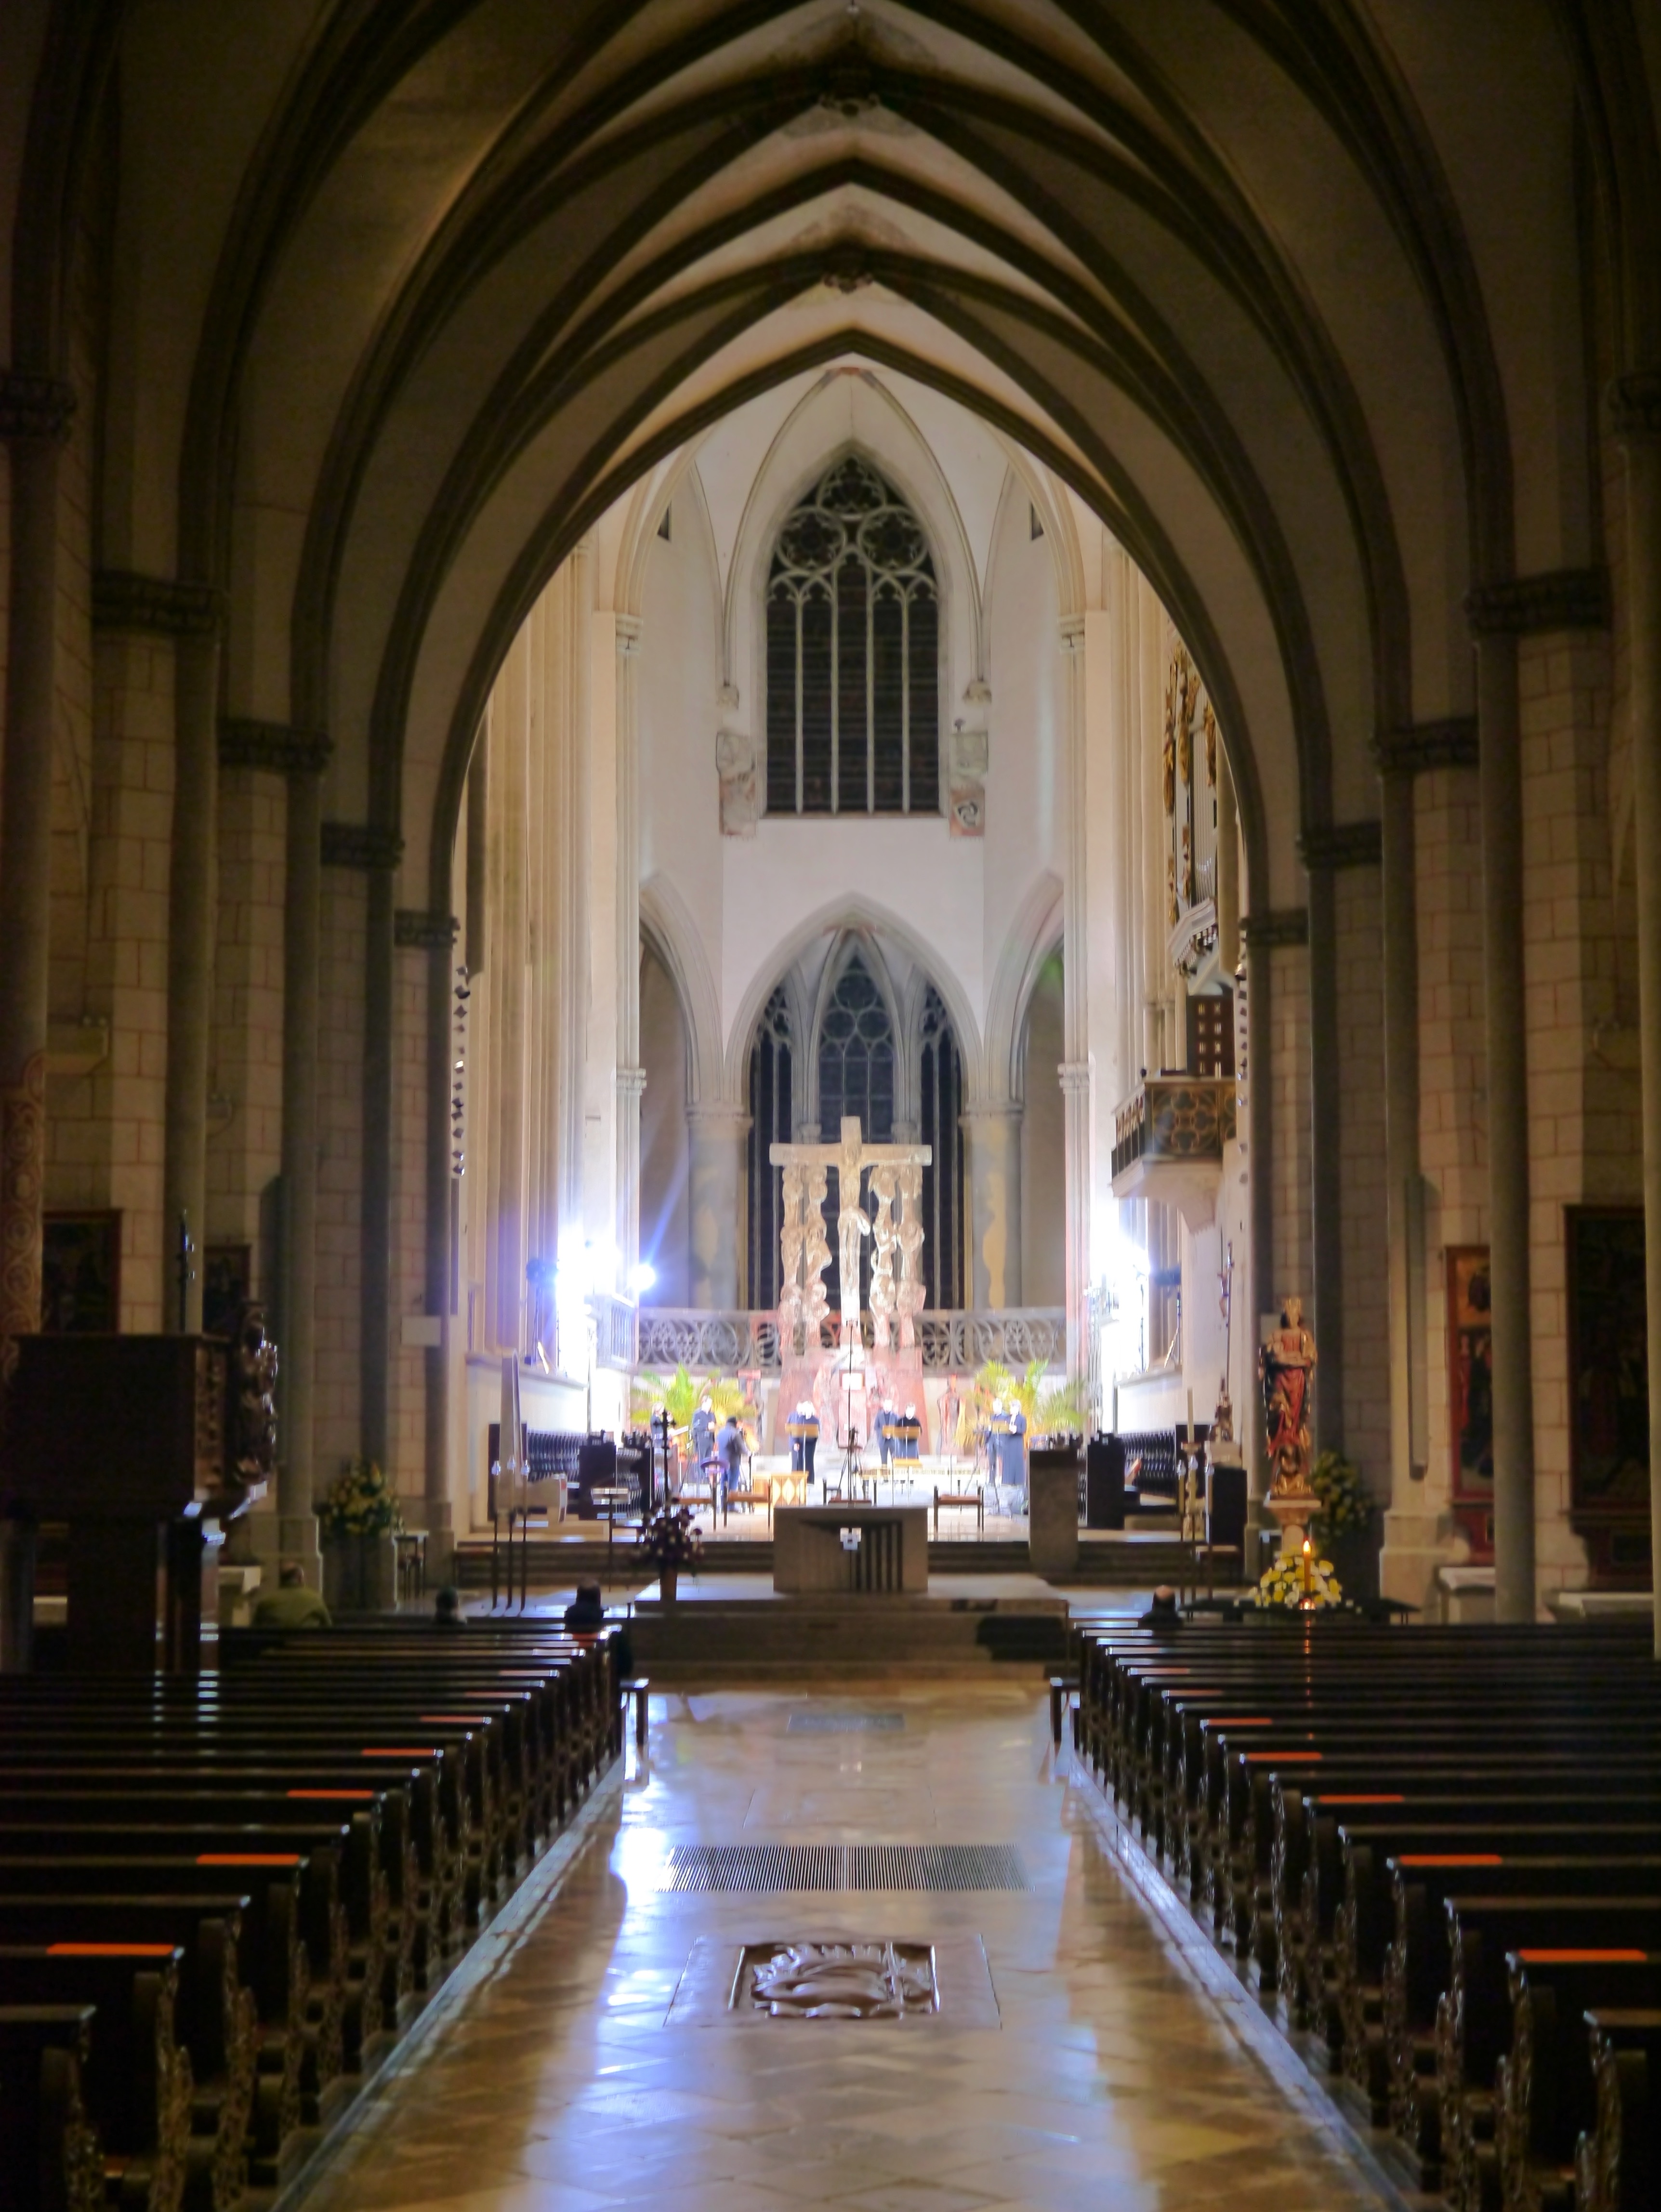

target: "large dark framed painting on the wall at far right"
[1566,1206,1650,1584]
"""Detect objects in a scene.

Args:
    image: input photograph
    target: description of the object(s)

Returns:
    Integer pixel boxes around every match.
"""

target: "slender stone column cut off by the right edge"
[1612,369,1661,1657]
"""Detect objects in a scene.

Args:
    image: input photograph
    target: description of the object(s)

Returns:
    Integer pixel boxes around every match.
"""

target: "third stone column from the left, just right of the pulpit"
[277,732,330,1588]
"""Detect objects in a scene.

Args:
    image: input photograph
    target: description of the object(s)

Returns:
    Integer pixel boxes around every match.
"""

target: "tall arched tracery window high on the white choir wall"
[767,456,940,814]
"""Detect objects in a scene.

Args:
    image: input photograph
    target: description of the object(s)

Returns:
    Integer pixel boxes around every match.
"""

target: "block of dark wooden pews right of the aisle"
[1073,1615,1661,2212]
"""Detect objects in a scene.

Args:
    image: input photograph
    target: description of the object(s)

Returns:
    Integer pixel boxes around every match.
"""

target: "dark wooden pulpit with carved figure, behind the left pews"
[2,1309,277,1674]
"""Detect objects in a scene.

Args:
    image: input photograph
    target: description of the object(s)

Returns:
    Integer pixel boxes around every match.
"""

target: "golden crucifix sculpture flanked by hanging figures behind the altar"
[767,1115,933,1356]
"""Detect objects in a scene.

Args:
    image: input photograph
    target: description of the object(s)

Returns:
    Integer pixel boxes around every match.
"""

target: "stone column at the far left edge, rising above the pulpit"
[0,374,75,1344]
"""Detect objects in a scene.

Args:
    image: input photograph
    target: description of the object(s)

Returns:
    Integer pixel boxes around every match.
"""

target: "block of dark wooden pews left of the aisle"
[0,1619,621,2212]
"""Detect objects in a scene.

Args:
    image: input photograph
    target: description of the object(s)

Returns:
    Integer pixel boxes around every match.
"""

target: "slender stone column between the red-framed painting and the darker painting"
[1466,584,1535,1621]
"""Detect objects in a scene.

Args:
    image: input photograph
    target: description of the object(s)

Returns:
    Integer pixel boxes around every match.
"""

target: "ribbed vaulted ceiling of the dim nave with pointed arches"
[0,0,1661,905]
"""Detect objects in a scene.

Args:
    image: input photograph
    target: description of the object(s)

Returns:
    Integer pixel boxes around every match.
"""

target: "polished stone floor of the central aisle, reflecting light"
[305,1681,1391,2212]
